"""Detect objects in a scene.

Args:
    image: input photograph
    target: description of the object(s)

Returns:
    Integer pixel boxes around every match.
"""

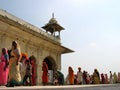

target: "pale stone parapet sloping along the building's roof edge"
[0,9,60,43]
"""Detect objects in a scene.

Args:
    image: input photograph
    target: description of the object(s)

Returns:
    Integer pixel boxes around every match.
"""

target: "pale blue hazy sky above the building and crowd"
[0,0,120,75]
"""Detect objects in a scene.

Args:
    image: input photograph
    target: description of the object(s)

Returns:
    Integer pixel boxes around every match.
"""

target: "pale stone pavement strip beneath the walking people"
[0,84,120,90]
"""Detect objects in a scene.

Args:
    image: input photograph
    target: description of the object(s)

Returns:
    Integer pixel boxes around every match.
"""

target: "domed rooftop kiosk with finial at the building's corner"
[42,13,64,38]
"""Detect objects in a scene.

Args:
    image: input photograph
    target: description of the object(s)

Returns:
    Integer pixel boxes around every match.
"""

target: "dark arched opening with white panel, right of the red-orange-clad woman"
[43,56,57,84]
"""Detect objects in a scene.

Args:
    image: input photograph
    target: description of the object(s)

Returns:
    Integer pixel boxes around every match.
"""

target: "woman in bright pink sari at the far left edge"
[0,48,9,85]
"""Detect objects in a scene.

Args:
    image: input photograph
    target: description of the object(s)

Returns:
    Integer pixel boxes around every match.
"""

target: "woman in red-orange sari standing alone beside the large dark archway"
[42,62,48,85]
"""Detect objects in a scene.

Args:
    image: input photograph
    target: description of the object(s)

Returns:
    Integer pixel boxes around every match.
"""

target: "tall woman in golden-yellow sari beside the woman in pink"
[7,41,22,86]
